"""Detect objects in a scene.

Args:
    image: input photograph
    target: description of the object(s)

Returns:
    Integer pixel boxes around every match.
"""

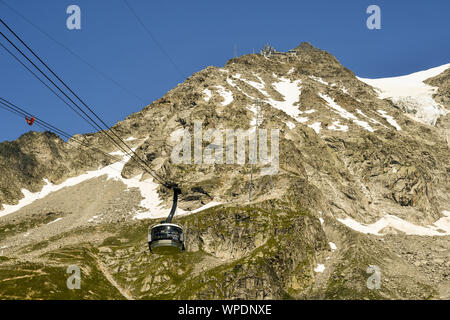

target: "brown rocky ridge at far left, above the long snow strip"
[0,132,109,209]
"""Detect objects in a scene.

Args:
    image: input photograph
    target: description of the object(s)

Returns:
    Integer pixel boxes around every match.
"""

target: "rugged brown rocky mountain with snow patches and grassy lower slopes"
[0,43,450,299]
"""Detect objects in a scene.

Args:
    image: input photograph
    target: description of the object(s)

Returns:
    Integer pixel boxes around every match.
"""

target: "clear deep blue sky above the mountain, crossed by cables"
[0,0,450,141]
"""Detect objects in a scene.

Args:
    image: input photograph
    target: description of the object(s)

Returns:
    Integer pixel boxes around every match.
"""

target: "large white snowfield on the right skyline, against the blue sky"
[358,63,450,126]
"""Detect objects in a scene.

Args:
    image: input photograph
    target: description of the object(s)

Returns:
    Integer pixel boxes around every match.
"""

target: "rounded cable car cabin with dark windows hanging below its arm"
[148,222,185,254]
